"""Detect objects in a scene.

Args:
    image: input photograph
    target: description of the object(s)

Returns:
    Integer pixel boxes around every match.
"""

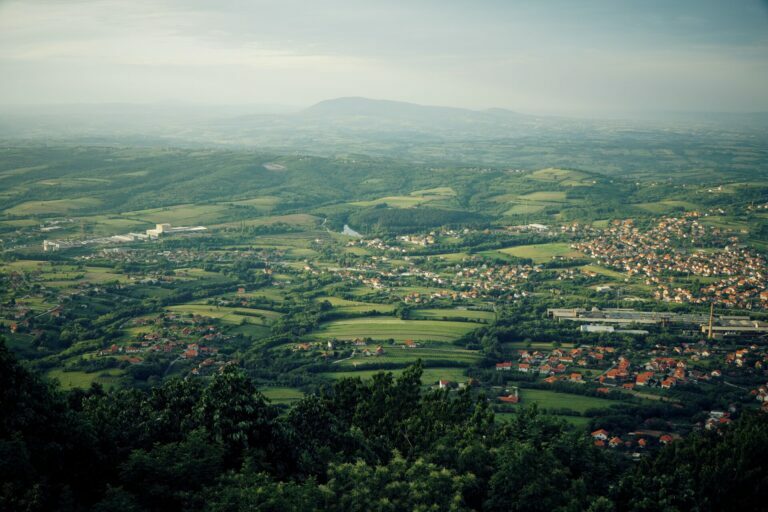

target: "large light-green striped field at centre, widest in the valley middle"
[313,317,477,342]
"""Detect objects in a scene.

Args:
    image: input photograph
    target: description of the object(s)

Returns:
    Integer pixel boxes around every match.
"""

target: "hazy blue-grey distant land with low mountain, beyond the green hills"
[0,97,768,173]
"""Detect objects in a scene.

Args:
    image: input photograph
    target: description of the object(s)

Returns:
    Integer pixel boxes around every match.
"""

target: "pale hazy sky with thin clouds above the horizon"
[0,0,768,113]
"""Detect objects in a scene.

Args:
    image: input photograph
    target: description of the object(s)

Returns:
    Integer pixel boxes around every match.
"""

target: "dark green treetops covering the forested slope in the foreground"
[0,342,768,512]
